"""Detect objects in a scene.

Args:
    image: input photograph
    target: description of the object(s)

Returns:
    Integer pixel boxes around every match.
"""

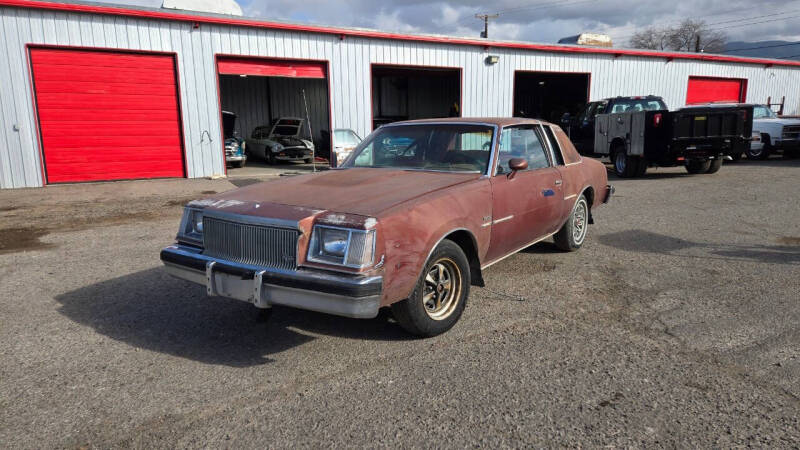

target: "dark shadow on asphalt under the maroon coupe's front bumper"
[56,268,409,367]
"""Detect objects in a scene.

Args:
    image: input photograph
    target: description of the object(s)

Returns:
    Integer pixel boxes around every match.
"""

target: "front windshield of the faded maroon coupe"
[342,124,494,173]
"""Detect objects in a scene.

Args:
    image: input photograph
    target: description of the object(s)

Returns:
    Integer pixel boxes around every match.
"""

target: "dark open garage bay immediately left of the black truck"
[514,71,591,123]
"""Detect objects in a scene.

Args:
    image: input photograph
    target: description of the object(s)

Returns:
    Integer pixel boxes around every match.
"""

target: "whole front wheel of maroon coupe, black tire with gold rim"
[392,239,470,337]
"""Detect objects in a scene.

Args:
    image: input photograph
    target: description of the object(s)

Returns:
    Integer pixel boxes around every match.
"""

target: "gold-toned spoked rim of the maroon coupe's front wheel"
[422,258,461,320]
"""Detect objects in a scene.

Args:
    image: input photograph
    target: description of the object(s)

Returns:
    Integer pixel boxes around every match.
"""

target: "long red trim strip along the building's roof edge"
[0,0,800,67]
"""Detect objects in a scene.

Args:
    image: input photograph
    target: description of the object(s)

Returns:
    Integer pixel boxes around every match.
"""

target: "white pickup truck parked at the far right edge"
[747,105,800,159]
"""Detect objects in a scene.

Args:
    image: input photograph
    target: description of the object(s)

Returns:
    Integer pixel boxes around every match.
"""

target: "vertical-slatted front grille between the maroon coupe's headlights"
[203,217,298,270]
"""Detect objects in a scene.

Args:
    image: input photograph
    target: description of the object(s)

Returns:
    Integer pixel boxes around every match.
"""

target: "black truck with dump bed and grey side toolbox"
[562,96,753,177]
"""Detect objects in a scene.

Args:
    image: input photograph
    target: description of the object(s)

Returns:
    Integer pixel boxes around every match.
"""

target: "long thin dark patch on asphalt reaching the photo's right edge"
[598,230,800,265]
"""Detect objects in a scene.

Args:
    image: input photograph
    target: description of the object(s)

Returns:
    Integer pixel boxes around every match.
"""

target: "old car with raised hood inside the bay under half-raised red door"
[247,117,314,164]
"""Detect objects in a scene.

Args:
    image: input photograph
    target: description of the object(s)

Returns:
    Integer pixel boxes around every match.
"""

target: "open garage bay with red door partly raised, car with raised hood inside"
[217,57,331,164]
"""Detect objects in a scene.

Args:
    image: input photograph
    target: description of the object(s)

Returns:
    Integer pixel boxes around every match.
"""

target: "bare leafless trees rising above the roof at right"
[630,19,728,53]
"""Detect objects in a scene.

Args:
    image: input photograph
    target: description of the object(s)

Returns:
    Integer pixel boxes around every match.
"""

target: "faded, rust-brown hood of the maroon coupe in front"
[200,168,480,220]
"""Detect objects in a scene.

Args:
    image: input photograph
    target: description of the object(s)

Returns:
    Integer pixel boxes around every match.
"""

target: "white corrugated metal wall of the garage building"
[0,3,800,188]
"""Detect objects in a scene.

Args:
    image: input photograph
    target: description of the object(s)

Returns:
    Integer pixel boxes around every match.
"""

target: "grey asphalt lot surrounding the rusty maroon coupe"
[0,159,800,448]
